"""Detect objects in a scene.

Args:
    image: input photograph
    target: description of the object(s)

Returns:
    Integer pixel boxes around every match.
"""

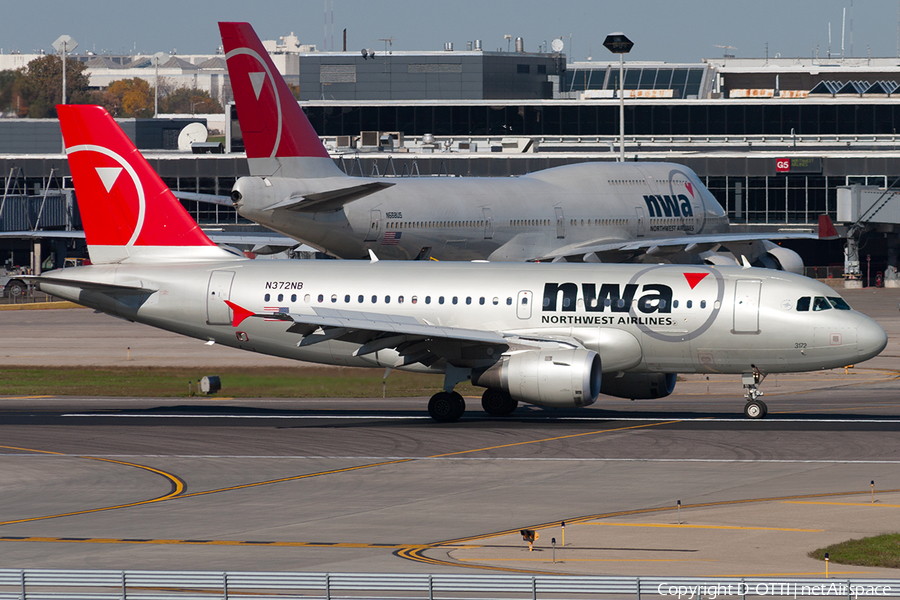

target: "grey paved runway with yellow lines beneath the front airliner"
[0,291,900,577]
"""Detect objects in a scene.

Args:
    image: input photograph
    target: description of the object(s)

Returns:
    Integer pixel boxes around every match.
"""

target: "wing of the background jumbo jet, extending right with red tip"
[535,231,819,260]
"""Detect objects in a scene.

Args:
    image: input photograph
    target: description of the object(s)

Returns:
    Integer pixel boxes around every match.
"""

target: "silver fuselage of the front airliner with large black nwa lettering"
[41,260,885,377]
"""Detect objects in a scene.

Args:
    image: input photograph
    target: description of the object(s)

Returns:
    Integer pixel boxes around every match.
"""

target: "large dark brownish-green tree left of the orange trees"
[11,54,93,118]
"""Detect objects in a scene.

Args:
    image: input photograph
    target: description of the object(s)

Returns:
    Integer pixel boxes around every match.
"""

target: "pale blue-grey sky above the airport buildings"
[0,0,900,62]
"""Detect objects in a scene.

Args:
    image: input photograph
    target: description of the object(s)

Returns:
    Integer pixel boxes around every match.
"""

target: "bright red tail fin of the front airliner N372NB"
[56,105,234,264]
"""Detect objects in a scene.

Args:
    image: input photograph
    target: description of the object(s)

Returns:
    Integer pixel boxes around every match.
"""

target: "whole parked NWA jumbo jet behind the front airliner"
[219,23,816,273]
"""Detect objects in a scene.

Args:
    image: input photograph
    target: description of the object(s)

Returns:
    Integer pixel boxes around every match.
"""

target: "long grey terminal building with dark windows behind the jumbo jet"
[0,42,900,284]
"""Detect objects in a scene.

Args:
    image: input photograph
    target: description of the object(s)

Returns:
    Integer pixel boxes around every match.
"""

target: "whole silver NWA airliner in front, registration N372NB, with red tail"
[31,106,887,421]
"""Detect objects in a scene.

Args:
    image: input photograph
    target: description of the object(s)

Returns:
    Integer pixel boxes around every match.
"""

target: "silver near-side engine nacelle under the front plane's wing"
[472,348,601,408]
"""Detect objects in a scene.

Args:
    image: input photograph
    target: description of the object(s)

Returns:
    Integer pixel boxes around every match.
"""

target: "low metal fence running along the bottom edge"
[0,569,900,600]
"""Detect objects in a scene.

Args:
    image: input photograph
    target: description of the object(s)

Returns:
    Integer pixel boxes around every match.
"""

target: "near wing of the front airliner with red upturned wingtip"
[226,301,513,367]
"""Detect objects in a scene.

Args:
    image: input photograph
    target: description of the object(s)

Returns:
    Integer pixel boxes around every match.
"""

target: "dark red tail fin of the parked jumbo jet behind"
[219,23,345,178]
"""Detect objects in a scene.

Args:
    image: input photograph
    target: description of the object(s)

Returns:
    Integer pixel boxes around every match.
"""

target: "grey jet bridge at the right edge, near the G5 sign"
[837,181,900,288]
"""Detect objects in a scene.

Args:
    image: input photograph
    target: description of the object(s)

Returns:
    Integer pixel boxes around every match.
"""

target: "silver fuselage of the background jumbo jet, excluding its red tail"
[233,163,732,263]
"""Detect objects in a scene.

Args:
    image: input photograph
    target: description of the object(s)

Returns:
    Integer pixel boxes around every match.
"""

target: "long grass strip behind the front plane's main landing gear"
[0,367,482,398]
